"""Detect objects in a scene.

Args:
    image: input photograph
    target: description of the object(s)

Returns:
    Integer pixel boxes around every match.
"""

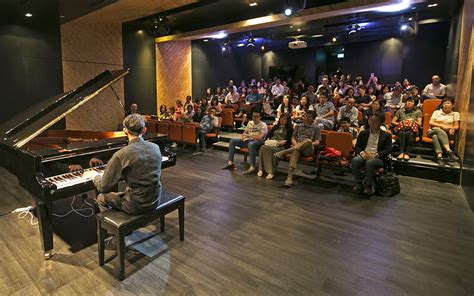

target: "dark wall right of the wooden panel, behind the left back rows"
[192,41,262,97]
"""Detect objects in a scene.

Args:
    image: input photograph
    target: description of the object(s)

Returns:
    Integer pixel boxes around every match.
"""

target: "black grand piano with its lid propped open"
[0,69,176,258]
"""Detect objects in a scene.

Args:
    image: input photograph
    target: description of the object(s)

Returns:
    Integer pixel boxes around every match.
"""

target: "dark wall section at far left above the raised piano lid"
[0,0,63,127]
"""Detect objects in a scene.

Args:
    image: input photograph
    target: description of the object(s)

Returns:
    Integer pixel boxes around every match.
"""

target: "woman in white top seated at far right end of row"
[428,99,461,165]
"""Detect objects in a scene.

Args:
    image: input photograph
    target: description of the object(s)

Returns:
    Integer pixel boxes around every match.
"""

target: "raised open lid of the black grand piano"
[0,69,129,148]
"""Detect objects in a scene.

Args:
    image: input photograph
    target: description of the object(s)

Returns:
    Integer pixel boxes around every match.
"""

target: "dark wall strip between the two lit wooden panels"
[122,24,156,114]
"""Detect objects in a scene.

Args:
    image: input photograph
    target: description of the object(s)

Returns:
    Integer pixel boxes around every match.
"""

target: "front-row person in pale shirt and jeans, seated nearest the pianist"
[222,111,268,175]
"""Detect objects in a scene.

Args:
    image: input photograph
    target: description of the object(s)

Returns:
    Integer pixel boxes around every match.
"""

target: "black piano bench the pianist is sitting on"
[96,191,185,280]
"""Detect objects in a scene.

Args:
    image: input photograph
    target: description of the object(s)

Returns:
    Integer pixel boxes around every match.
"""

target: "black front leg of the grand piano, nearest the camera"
[36,203,53,260]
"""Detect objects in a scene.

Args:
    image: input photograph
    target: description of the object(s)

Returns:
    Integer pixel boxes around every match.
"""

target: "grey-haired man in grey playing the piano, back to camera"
[84,114,162,214]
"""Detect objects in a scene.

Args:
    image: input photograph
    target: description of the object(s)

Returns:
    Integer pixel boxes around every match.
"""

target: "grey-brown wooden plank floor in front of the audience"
[0,151,474,296]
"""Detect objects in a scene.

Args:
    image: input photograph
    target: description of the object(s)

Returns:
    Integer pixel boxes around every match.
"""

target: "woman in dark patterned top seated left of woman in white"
[392,98,421,160]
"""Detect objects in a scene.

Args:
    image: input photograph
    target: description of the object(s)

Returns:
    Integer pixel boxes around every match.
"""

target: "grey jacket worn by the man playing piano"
[94,137,161,214]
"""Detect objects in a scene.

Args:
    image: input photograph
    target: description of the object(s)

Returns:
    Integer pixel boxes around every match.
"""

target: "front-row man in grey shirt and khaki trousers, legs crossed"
[275,111,321,187]
